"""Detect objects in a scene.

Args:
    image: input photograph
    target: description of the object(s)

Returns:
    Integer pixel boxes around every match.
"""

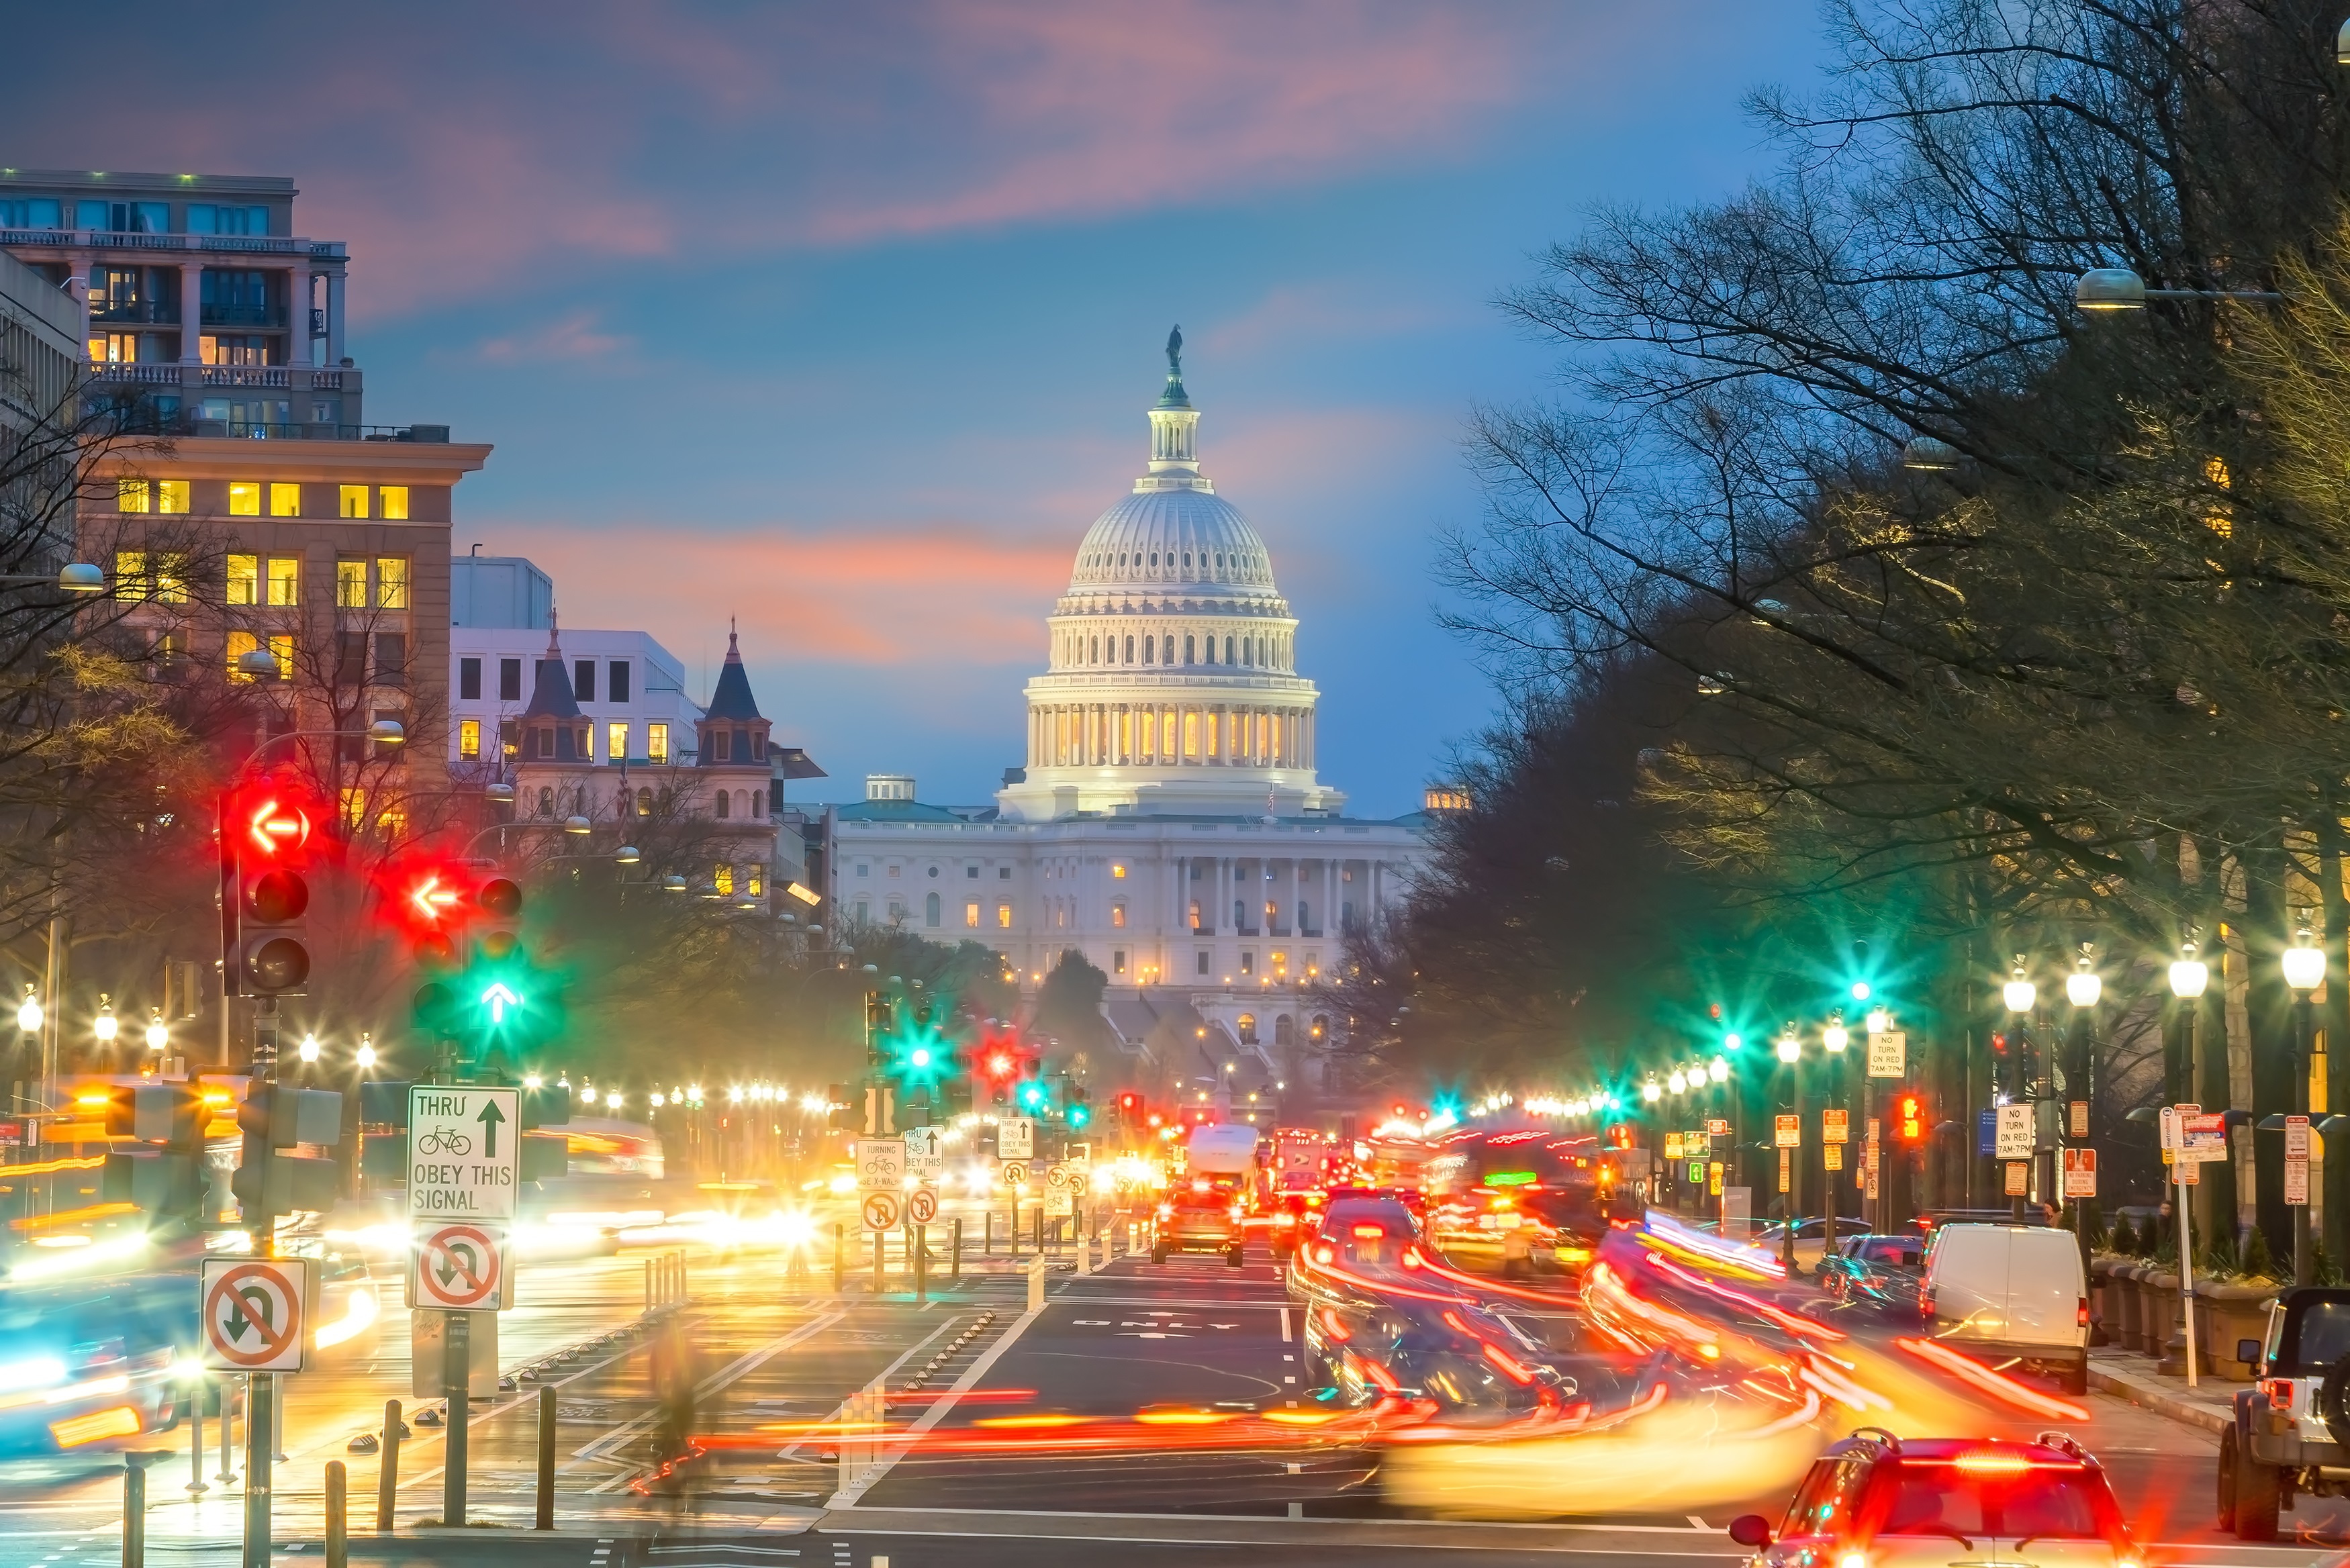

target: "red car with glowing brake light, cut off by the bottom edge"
[1730,1427,2146,1568]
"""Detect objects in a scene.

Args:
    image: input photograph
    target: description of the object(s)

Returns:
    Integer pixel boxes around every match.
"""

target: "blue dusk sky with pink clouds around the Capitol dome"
[0,0,1822,816]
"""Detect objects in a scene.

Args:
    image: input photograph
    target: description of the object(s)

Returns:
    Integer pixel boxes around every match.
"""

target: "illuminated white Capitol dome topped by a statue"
[996,332,1344,820]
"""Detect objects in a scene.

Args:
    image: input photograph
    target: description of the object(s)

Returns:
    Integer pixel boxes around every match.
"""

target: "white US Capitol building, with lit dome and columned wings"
[825,334,1429,1114]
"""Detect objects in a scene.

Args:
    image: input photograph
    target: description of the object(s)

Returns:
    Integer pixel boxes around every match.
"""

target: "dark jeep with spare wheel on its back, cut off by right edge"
[2216,1286,2350,1540]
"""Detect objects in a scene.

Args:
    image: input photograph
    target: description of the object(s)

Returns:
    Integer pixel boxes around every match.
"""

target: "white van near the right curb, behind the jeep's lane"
[1920,1225,2089,1394]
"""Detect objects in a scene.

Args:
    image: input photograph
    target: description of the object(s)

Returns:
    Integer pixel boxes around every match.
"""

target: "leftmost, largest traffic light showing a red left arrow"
[221,781,313,997]
